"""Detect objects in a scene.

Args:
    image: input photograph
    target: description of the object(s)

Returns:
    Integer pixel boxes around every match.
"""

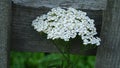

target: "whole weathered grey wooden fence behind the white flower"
[0,0,120,68]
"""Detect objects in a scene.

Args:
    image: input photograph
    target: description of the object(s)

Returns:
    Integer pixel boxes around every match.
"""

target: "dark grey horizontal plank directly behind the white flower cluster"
[11,5,102,55]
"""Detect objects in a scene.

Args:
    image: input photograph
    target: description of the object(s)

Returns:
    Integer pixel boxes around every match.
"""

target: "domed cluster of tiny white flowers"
[32,7,100,45]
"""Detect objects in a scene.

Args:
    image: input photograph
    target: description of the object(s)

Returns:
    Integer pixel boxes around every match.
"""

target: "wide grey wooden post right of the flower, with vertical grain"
[96,0,120,68]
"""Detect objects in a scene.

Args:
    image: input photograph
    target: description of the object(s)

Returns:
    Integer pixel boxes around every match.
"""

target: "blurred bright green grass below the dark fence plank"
[10,51,95,68]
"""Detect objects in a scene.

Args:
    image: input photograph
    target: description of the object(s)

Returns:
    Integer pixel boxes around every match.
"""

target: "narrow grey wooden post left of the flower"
[0,0,11,68]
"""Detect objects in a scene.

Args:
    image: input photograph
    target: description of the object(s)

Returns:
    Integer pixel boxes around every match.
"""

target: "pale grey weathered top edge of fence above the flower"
[12,0,107,10]
